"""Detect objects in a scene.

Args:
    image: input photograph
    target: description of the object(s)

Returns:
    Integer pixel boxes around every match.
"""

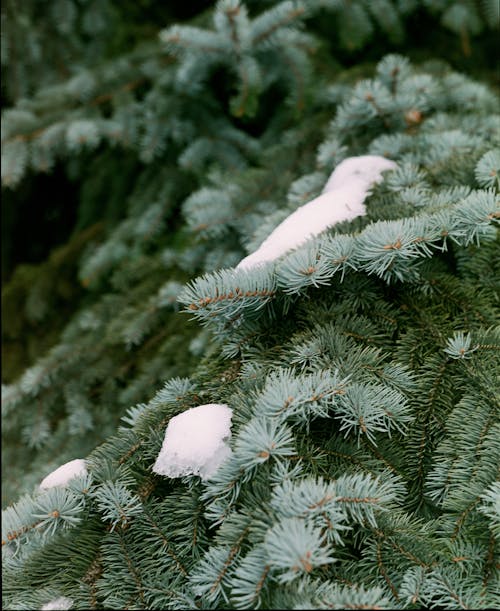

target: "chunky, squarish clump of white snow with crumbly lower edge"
[153,403,233,479]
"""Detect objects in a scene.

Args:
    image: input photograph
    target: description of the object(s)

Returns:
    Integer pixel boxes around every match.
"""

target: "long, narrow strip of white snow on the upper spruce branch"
[236,155,397,269]
